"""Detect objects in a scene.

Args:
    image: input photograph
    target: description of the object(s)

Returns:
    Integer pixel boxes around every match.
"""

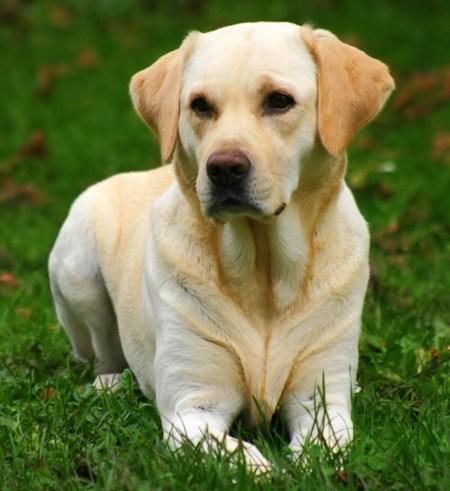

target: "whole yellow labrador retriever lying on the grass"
[49,23,394,472]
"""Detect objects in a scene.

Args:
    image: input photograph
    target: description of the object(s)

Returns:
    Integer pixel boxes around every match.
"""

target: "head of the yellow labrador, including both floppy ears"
[130,23,394,221]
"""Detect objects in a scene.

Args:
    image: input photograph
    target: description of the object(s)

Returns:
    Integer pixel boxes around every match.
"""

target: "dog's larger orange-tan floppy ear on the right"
[301,27,395,157]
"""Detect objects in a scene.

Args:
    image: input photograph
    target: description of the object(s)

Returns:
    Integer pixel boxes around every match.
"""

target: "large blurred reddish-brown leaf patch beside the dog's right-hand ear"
[392,66,450,120]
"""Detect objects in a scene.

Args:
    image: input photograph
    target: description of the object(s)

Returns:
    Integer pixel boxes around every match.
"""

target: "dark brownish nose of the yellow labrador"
[206,150,250,188]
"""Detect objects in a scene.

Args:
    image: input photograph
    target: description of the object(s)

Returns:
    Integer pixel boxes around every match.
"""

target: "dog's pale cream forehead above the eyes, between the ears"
[184,22,315,90]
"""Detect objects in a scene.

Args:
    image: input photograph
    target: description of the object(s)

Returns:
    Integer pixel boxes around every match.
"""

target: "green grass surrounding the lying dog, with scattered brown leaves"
[0,0,450,490]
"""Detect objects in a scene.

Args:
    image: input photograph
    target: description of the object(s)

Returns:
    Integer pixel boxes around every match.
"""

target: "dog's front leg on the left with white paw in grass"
[155,323,270,474]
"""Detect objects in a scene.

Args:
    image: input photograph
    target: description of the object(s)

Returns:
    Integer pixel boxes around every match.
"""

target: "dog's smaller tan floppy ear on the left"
[130,49,183,162]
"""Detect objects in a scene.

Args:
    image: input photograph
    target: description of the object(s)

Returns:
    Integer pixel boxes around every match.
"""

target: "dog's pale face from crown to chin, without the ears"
[178,24,316,220]
